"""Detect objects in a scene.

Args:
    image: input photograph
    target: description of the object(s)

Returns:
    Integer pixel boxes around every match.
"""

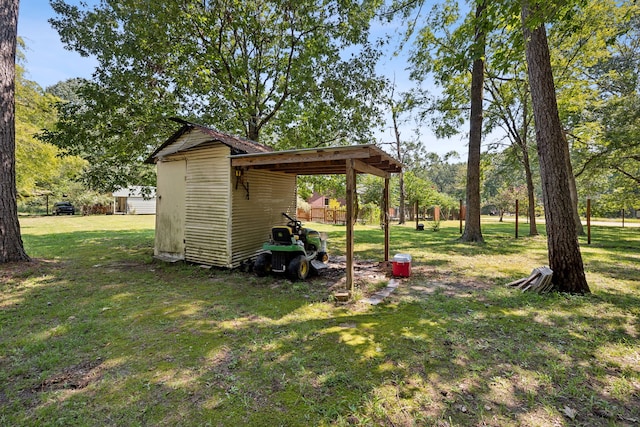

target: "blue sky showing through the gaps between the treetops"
[18,0,466,158]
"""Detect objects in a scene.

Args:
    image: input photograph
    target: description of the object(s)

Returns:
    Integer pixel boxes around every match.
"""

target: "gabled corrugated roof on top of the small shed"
[145,118,273,163]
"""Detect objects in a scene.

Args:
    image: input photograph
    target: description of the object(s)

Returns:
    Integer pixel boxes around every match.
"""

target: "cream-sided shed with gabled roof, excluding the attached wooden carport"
[147,119,296,268]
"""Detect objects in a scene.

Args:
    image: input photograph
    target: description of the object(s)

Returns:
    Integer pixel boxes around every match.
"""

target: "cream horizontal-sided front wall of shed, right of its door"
[185,144,230,267]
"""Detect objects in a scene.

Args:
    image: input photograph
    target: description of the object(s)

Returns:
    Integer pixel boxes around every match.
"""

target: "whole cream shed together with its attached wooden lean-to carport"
[147,119,402,288]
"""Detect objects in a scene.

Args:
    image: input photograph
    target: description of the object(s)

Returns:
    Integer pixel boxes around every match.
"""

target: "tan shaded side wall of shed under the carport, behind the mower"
[231,170,296,267]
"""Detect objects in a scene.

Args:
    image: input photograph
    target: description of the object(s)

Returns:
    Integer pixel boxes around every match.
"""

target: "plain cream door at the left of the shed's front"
[155,160,187,259]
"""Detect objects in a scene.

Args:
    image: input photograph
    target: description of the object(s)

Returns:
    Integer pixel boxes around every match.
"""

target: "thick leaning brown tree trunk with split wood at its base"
[522,0,590,293]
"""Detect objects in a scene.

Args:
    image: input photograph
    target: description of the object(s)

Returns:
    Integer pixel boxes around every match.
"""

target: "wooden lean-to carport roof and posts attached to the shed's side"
[230,144,402,291]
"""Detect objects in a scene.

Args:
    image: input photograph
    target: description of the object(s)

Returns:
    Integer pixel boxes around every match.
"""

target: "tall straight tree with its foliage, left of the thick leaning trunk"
[405,0,491,242]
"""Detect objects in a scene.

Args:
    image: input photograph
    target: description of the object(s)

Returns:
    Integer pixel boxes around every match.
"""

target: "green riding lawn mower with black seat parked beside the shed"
[253,212,329,280]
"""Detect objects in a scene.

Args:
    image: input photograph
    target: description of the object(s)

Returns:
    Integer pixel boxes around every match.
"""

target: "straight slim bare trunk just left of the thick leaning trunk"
[460,0,486,242]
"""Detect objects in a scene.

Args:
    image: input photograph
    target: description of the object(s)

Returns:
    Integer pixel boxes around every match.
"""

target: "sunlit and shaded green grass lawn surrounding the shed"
[0,216,640,427]
